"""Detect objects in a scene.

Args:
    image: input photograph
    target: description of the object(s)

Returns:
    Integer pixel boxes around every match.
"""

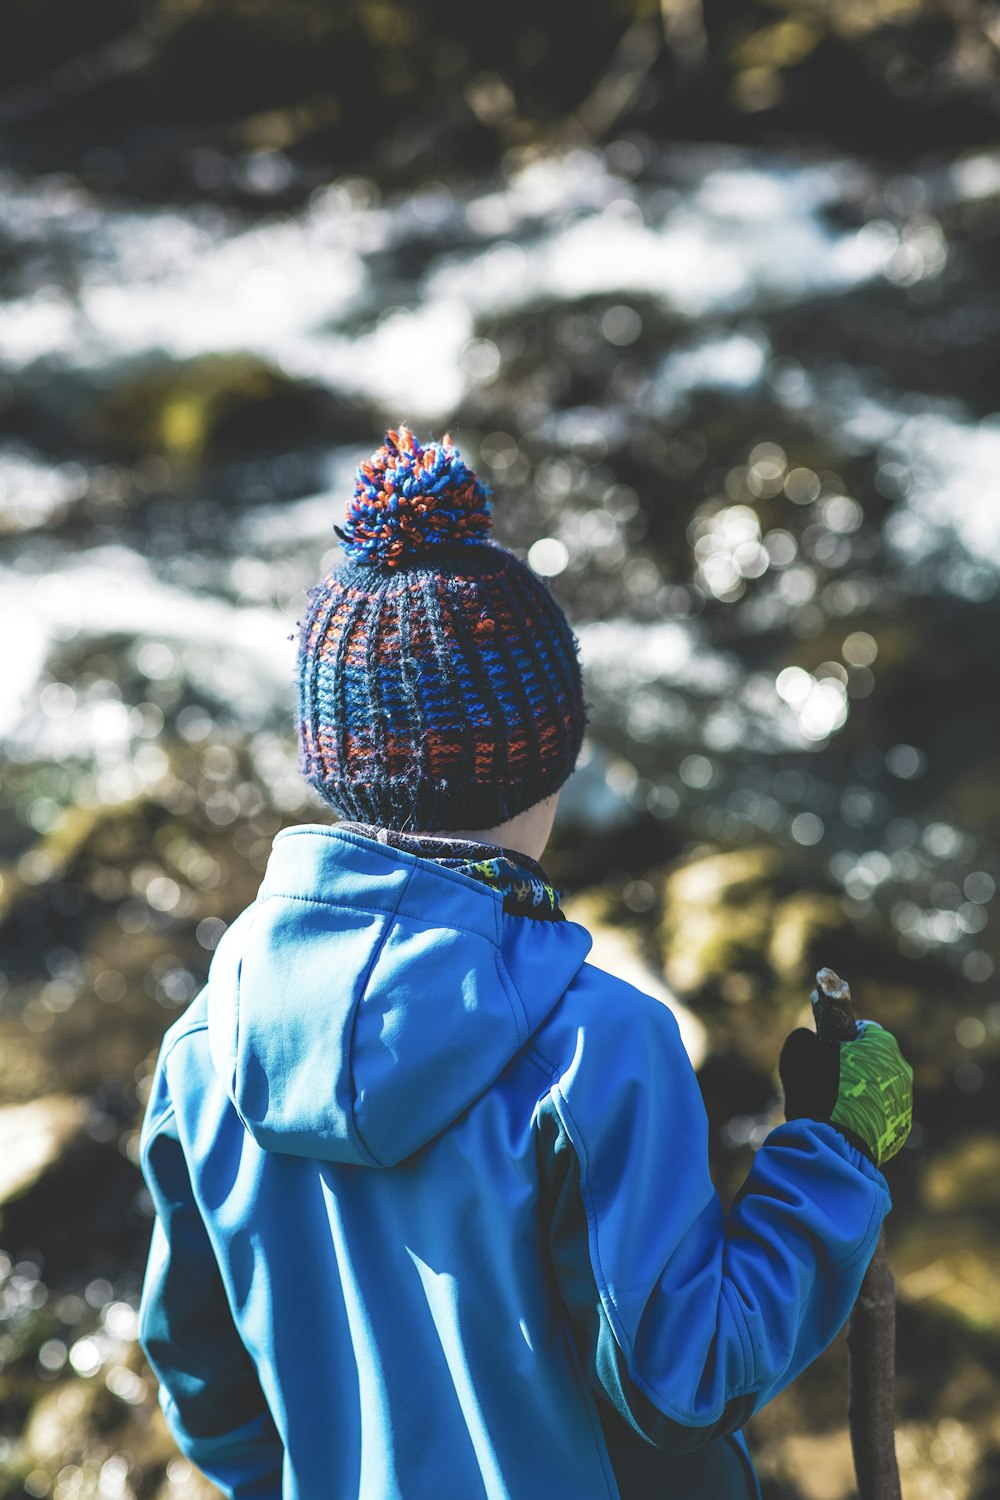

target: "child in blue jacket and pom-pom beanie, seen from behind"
[141,428,912,1500]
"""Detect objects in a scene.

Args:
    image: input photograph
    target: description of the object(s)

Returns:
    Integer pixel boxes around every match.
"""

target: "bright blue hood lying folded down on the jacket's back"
[208,827,591,1167]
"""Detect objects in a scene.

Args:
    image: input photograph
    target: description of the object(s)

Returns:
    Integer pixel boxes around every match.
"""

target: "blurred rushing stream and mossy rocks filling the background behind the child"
[0,0,1000,1500]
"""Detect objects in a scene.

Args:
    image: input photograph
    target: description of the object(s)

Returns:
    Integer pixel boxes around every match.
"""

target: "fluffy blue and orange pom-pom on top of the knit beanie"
[333,426,490,569]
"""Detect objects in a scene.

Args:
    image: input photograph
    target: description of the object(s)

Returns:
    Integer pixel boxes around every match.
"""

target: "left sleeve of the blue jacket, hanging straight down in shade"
[139,1074,283,1500]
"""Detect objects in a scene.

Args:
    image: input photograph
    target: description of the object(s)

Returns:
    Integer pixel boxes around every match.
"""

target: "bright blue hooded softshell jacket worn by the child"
[141,827,889,1500]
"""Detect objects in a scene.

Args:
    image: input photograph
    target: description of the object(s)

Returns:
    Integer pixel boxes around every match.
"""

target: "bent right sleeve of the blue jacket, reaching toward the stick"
[538,975,889,1452]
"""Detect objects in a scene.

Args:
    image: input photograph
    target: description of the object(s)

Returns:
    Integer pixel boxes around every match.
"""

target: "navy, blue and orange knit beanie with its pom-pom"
[298,426,586,831]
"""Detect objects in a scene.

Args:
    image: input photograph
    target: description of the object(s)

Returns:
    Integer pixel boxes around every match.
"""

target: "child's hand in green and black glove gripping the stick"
[778,1022,913,1167]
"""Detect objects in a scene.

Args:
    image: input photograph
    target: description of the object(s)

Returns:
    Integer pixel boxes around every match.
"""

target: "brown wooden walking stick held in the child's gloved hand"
[811,969,901,1500]
